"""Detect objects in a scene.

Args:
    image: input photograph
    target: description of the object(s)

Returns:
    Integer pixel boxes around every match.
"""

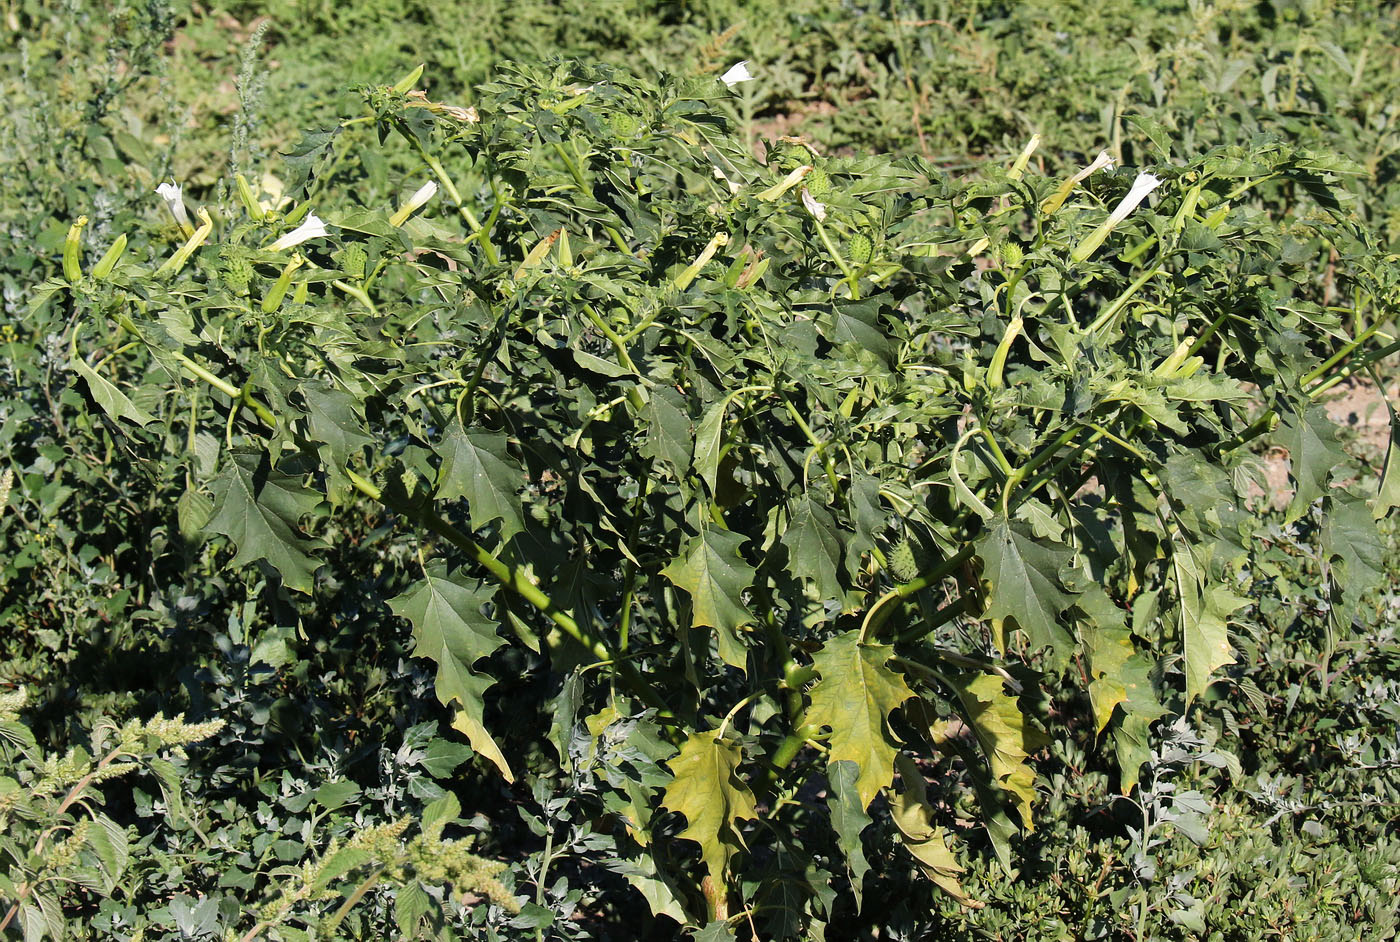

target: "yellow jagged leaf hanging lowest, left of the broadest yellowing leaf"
[661,731,759,885]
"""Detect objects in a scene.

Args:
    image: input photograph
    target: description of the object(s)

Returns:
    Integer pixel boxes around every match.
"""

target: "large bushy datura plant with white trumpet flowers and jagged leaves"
[46,63,1400,928]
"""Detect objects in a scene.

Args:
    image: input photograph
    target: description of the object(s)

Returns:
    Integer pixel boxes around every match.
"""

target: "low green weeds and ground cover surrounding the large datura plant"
[0,0,1400,939]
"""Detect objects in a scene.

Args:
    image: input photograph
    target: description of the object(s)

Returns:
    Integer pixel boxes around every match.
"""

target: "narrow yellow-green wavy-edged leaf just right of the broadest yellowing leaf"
[951,673,1049,831]
